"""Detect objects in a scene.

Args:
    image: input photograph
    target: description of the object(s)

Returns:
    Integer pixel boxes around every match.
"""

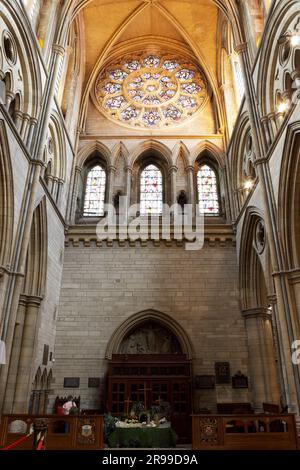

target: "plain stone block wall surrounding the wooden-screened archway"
[50,237,248,410]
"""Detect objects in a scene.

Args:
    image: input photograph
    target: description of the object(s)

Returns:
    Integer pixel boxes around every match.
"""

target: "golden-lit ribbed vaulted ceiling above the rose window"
[75,0,225,85]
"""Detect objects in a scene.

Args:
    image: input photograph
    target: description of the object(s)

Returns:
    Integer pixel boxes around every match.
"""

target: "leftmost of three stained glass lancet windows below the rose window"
[83,165,106,217]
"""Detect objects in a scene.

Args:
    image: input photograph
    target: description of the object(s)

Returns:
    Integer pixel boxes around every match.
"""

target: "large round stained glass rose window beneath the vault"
[95,54,208,129]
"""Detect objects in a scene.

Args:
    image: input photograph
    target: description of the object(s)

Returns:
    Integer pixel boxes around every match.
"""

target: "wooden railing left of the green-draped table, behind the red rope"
[0,414,103,450]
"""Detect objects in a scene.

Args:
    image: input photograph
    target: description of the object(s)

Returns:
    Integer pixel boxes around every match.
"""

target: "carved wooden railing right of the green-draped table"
[193,414,298,450]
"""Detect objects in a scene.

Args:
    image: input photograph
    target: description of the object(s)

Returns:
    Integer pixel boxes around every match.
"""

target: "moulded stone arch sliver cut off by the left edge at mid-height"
[0,121,14,266]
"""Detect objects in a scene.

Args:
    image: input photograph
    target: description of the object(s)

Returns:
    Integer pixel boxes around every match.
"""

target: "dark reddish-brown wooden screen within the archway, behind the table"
[107,354,191,442]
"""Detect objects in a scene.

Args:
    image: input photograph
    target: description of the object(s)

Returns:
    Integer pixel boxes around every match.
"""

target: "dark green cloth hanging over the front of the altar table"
[108,428,178,449]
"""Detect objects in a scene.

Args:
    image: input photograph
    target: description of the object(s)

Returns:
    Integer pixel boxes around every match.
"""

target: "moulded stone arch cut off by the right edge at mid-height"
[278,122,300,269]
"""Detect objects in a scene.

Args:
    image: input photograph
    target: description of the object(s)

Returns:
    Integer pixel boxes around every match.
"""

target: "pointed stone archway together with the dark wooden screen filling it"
[107,310,192,442]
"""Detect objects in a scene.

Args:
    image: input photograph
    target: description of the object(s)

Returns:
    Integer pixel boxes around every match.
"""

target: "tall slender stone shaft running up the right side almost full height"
[236,43,300,414]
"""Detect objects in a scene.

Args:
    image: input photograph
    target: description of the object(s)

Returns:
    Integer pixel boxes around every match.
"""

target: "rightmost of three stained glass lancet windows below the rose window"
[197,164,220,215]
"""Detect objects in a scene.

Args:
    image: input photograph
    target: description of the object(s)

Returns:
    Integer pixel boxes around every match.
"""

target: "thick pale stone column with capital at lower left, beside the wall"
[13,296,42,413]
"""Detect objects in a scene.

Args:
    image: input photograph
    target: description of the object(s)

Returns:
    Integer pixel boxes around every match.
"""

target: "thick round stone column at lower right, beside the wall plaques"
[243,307,280,411]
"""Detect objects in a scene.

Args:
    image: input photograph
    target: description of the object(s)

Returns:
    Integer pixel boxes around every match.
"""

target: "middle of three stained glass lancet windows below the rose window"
[140,165,163,215]
